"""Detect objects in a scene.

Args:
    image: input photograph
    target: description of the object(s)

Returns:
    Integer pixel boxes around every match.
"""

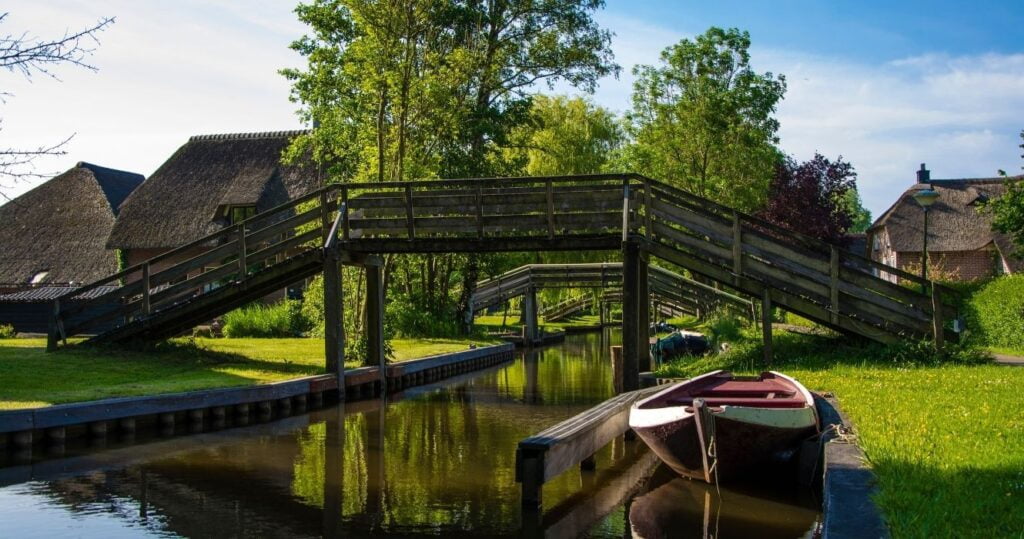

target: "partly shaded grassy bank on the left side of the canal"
[0,338,496,410]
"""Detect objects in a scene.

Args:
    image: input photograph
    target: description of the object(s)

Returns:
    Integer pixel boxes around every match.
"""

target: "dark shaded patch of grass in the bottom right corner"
[871,459,1024,537]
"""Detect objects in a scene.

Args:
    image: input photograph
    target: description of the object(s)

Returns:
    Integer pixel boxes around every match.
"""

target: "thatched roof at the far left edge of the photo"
[0,163,144,285]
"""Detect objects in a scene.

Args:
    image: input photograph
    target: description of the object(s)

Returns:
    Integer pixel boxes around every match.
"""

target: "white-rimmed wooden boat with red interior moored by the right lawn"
[630,371,818,483]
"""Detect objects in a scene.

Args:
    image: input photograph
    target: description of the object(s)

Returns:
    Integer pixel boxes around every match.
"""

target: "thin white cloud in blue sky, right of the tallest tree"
[595,15,1024,215]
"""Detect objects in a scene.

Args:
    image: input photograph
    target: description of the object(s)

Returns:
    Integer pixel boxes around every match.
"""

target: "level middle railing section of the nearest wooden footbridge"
[342,174,639,251]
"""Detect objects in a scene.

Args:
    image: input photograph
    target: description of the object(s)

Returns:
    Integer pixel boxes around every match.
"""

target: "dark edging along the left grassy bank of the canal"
[0,343,514,450]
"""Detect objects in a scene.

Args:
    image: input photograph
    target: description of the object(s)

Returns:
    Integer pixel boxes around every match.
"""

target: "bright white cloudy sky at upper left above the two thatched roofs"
[0,0,303,199]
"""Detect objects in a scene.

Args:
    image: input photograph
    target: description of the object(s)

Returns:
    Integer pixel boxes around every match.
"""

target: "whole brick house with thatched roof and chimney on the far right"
[867,165,1024,281]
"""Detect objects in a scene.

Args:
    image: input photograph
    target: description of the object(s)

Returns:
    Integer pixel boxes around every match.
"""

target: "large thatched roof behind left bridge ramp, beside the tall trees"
[108,131,319,249]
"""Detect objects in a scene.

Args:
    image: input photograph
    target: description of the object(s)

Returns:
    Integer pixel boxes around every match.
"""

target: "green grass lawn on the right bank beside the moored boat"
[658,332,1024,537]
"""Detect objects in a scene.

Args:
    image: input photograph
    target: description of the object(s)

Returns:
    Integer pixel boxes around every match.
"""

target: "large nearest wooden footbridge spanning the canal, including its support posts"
[49,174,955,395]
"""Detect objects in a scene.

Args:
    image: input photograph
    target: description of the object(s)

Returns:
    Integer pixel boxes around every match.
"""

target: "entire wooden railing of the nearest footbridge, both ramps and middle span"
[50,174,955,346]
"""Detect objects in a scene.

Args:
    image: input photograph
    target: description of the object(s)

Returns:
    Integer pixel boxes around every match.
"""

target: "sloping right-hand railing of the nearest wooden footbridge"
[645,182,955,336]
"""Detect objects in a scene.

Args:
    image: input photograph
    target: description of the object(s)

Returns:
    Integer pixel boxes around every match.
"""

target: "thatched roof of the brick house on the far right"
[868,176,1024,252]
